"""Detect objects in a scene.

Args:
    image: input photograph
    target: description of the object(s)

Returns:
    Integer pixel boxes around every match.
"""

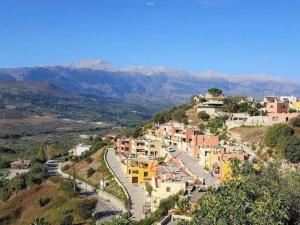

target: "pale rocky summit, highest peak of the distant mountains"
[66,59,117,71]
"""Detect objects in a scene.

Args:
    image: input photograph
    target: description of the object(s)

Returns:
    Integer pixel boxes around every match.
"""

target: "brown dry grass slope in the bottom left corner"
[0,181,95,225]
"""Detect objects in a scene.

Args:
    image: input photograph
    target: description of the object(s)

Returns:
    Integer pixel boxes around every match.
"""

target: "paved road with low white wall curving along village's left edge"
[107,149,147,220]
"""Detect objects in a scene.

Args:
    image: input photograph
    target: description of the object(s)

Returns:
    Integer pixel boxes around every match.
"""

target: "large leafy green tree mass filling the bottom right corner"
[181,162,300,225]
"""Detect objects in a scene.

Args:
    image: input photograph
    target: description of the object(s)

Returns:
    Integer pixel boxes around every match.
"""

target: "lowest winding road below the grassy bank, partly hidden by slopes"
[46,160,122,224]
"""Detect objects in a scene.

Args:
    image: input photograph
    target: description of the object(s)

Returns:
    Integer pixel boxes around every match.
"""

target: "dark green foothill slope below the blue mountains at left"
[0,81,153,123]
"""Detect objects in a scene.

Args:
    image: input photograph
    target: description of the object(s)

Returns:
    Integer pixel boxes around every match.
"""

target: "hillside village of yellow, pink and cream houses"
[110,88,300,221]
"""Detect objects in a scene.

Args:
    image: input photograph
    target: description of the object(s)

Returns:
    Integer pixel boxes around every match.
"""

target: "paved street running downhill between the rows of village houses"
[171,150,219,185]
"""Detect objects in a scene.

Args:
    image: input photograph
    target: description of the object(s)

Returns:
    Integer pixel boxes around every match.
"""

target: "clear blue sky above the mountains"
[0,0,300,79]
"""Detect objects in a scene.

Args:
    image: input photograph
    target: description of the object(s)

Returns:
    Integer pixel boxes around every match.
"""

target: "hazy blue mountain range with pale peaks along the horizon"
[0,60,300,107]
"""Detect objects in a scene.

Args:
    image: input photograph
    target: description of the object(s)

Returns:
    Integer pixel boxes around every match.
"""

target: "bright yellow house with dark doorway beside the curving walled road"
[122,158,157,184]
